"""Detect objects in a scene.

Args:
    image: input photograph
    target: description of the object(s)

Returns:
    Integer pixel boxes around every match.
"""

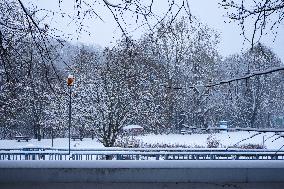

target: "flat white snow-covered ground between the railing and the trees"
[0,132,284,149]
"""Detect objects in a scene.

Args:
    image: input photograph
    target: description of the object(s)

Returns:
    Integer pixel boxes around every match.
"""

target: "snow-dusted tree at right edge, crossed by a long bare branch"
[217,44,283,127]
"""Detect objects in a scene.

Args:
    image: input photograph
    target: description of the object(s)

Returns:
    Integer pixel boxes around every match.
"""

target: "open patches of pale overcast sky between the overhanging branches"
[24,0,284,62]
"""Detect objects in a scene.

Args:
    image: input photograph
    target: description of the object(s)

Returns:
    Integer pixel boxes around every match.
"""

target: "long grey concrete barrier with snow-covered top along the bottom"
[0,160,284,189]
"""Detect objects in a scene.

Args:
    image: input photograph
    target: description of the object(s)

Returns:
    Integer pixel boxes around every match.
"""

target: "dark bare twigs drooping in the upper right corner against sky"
[220,0,284,46]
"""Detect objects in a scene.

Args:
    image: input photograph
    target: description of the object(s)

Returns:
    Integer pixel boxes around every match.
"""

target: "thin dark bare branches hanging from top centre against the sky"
[66,0,191,37]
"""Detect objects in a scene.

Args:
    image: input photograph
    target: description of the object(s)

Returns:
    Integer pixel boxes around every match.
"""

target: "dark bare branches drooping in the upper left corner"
[0,0,63,86]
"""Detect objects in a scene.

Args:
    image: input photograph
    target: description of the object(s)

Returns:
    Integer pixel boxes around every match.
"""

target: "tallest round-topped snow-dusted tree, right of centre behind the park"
[144,19,219,131]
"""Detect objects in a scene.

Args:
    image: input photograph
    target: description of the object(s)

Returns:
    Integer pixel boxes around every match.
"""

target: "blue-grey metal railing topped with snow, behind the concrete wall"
[0,148,284,160]
